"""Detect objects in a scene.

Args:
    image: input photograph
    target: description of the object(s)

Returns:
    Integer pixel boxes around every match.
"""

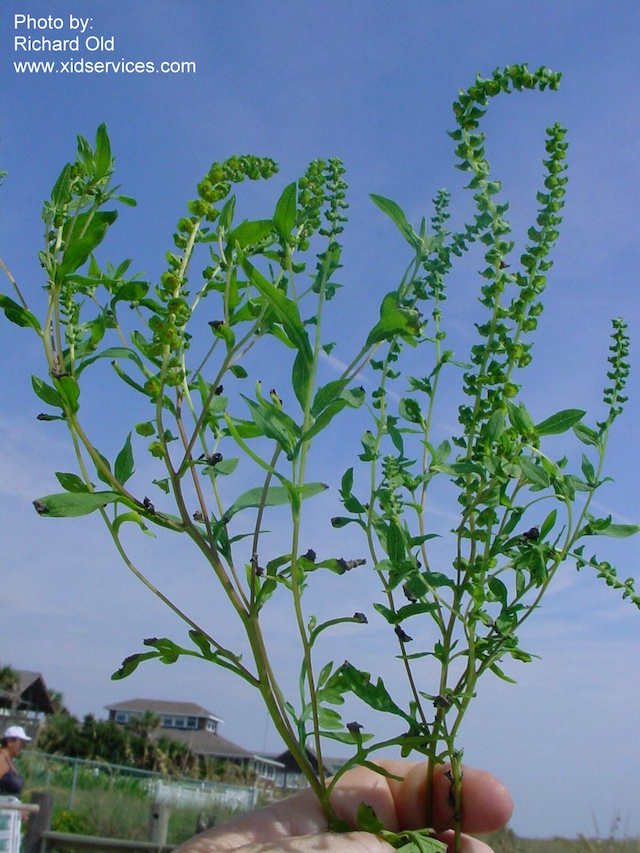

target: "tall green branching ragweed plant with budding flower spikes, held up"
[0,65,640,853]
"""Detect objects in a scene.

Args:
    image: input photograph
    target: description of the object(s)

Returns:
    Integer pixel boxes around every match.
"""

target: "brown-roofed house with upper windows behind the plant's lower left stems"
[105,699,282,782]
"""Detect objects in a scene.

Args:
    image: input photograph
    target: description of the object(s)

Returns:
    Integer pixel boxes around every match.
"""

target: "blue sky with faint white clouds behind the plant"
[0,0,640,836]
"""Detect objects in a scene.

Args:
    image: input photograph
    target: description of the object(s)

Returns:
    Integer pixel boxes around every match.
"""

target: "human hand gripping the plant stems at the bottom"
[175,761,513,853]
